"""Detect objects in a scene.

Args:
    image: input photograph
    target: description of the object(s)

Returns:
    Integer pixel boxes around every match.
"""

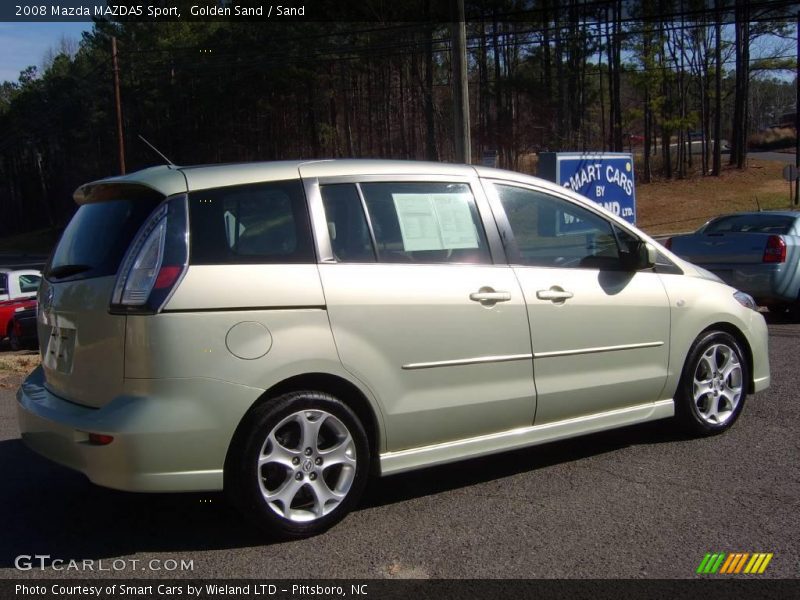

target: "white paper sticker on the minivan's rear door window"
[392,194,478,252]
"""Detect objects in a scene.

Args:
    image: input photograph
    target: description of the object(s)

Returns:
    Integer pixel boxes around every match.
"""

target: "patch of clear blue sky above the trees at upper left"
[0,22,92,81]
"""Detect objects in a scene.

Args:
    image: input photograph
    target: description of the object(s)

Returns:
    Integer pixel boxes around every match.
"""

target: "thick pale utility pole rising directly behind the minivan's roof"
[450,0,472,164]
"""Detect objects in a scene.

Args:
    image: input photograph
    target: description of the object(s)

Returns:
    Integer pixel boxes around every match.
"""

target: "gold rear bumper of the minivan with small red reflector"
[17,367,263,492]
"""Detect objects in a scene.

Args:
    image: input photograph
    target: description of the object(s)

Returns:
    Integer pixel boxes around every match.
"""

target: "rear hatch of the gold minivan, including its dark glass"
[39,184,174,407]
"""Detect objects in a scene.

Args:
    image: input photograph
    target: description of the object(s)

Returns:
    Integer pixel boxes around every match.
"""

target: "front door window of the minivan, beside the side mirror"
[495,185,638,269]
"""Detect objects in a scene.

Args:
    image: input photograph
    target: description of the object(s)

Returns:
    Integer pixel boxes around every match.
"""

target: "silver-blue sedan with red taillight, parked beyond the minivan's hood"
[667,211,800,316]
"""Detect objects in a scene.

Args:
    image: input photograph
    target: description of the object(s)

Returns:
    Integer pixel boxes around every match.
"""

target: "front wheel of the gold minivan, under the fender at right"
[675,331,750,436]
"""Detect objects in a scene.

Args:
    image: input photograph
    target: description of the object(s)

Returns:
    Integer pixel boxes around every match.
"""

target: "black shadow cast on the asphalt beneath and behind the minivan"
[0,422,681,568]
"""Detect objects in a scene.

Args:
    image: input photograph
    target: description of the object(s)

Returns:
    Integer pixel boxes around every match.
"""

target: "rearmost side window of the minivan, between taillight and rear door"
[189,180,315,265]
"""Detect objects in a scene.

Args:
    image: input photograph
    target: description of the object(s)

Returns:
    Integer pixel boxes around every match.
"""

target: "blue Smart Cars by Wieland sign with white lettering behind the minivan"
[539,152,636,224]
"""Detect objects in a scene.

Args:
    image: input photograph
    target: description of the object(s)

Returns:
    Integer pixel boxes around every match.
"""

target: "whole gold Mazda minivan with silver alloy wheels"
[17,160,770,537]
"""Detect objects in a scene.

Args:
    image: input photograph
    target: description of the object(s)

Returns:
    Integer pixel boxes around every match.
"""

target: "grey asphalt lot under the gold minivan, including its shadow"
[0,315,800,579]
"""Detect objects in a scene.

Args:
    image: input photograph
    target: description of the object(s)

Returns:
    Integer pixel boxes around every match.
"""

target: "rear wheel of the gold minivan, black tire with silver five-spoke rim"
[225,391,370,539]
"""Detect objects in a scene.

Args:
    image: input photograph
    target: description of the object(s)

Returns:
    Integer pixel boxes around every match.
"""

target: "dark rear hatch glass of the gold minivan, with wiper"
[45,198,162,281]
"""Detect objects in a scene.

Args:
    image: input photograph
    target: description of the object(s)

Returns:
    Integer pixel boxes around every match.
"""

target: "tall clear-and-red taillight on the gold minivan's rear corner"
[111,195,189,314]
